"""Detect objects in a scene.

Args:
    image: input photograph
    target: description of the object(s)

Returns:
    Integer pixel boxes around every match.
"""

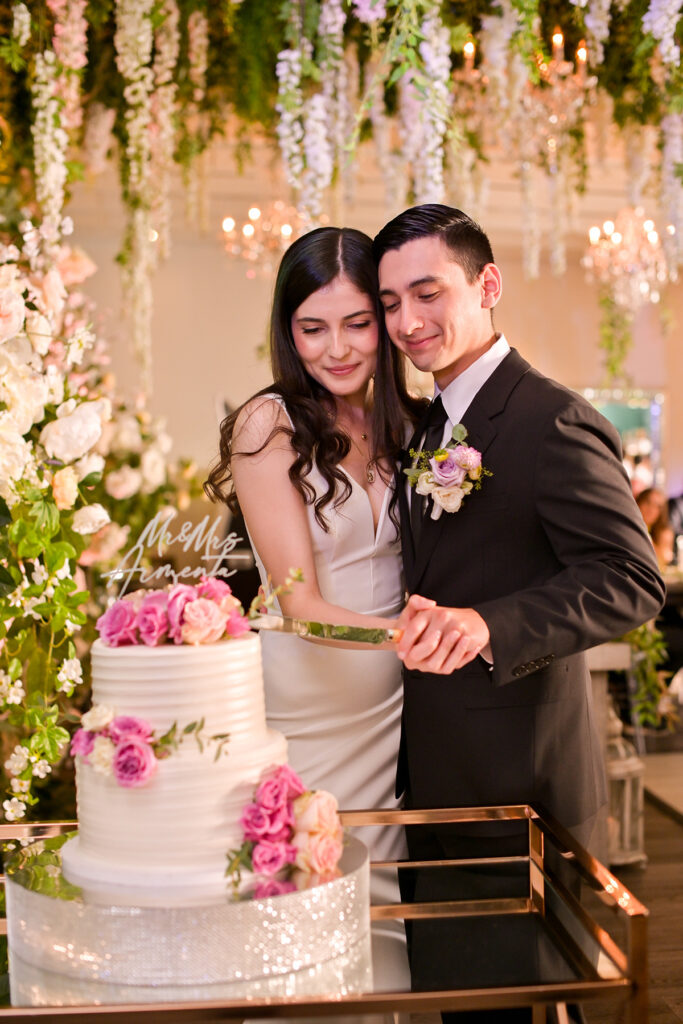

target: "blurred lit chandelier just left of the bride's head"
[221,200,312,279]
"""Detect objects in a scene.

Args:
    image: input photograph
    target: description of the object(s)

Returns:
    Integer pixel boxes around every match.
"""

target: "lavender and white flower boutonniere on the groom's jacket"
[403,423,494,519]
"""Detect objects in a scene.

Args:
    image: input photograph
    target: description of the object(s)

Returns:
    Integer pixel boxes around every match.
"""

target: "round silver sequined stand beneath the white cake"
[6,836,372,1006]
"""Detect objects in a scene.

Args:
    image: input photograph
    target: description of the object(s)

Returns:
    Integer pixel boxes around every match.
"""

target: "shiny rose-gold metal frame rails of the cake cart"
[0,805,648,1024]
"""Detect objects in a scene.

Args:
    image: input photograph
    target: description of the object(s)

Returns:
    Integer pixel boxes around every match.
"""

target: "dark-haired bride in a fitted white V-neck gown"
[207,227,421,984]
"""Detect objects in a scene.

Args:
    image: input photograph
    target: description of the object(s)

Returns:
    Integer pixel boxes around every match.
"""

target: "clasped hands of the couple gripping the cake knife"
[396,594,490,675]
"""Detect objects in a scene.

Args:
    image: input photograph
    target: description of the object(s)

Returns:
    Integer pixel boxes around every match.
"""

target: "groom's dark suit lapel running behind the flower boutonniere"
[407,348,529,592]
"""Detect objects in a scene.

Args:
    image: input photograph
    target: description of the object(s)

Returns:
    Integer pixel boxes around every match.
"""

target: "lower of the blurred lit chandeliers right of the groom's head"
[582,201,670,314]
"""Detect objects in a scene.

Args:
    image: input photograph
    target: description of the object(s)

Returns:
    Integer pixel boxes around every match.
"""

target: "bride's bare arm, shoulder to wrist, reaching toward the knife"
[231,398,396,629]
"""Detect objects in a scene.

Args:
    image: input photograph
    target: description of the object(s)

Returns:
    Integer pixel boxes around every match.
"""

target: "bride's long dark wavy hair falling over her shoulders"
[204,227,424,530]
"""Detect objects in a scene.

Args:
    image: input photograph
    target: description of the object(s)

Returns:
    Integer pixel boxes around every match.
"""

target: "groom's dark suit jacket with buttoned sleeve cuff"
[397,349,664,826]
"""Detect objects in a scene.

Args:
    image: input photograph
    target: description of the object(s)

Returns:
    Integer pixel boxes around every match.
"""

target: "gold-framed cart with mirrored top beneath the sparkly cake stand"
[0,806,647,1024]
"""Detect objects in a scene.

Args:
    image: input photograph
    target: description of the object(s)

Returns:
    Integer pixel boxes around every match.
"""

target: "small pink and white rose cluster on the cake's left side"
[71,705,157,786]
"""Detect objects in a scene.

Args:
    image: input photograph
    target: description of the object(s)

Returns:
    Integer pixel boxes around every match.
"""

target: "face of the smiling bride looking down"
[292,275,378,401]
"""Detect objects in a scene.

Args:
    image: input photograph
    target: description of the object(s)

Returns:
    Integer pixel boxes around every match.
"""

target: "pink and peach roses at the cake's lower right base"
[225,765,343,898]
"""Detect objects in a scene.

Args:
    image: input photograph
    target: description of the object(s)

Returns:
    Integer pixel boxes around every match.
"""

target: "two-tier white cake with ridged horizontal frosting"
[62,633,287,902]
